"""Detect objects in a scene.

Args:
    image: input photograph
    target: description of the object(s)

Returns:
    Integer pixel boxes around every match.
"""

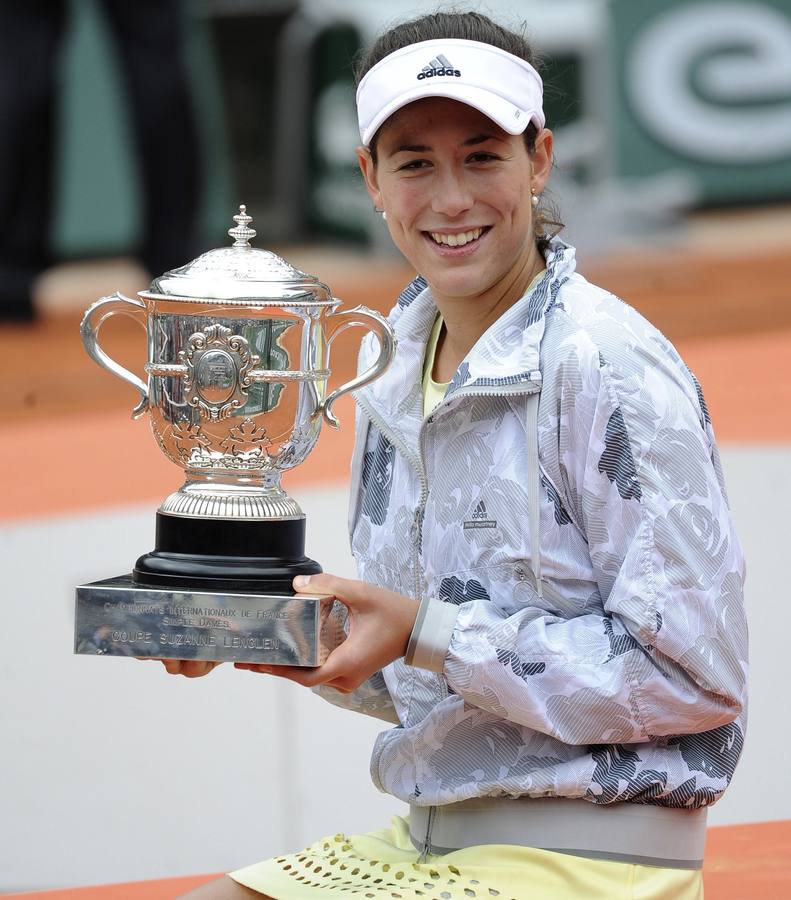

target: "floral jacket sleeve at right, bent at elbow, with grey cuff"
[413,330,747,744]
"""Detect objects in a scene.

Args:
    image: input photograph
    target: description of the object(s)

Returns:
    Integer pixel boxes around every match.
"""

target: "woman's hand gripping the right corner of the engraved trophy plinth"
[235,573,420,694]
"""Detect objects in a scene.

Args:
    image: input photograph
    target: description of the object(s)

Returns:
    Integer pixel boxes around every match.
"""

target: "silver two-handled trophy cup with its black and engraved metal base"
[75,206,395,666]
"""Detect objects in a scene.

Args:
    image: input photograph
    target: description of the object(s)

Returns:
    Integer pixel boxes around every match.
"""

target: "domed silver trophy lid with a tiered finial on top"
[141,205,336,305]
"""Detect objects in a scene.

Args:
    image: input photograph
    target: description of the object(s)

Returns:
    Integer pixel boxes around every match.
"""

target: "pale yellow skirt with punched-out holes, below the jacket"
[230,816,703,900]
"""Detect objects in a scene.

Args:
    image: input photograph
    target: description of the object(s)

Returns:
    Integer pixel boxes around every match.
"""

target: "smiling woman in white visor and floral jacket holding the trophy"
[179,13,746,900]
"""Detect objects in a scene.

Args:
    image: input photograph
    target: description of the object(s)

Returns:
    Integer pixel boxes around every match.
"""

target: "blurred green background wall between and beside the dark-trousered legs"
[52,0,229,262]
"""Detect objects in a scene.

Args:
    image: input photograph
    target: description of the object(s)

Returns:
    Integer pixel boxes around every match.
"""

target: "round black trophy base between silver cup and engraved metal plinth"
[132,513,321,596]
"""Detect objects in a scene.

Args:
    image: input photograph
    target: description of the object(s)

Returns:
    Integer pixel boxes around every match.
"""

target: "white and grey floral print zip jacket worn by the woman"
[320,239,747,808]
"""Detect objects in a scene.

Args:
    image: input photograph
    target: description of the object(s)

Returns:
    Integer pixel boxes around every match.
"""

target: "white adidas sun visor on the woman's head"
[357,38,545,147]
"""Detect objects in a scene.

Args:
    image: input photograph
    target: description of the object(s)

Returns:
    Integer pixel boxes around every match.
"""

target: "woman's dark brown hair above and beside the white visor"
[354,12,563,254]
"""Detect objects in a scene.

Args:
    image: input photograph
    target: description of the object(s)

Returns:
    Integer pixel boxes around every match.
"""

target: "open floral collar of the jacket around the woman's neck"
[355,238,576,444]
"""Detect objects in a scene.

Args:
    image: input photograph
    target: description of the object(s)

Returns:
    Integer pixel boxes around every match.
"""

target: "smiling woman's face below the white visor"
[358,97,552,298]
